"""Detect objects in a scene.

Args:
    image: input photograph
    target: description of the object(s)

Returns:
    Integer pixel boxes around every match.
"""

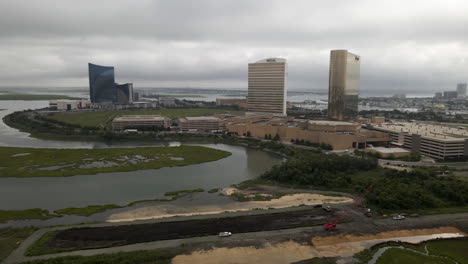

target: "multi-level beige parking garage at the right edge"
[371,122,468,160]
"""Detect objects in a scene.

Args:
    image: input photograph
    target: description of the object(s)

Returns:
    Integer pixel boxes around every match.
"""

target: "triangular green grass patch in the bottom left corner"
[0,227,37,262]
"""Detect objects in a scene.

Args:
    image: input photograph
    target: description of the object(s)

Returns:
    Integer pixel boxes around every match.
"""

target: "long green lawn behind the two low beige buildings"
[49,108,244,127]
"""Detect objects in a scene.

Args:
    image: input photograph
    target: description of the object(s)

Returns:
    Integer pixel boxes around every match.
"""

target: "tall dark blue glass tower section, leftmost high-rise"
[88,63,117,104]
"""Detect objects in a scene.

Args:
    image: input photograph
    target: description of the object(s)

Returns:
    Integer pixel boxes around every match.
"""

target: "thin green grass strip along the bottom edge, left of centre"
[23,250,181,264]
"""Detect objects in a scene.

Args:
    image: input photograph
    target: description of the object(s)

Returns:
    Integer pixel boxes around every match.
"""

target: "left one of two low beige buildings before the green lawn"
[112,115,170,131]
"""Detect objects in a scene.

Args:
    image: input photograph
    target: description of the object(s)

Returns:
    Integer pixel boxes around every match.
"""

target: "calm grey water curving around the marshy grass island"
[0,101,281,209]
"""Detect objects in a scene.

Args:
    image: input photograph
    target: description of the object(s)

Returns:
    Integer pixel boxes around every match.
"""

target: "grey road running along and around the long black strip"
[3,209,468,264]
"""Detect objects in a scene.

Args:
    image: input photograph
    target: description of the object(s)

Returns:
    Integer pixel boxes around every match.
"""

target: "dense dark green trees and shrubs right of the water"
[262,152,468,210]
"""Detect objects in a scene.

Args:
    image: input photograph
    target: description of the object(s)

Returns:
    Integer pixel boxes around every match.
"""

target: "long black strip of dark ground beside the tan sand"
[48,209,330,248]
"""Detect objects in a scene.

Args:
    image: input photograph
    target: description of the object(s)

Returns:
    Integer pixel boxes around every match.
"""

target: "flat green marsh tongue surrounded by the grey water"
[0,146,231,177]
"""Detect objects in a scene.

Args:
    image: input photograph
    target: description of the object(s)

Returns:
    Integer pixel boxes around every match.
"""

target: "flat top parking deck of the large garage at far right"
[375,122,468,141]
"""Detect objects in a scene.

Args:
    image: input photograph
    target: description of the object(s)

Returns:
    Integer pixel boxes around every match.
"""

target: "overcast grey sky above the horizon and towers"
[0,0,468,93]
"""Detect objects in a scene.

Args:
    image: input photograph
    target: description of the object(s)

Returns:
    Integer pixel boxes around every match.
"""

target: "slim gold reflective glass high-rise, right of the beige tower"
[328,50,360,120]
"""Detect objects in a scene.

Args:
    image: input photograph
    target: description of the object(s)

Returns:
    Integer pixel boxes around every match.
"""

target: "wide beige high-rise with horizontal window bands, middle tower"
[247,58,288,115]
